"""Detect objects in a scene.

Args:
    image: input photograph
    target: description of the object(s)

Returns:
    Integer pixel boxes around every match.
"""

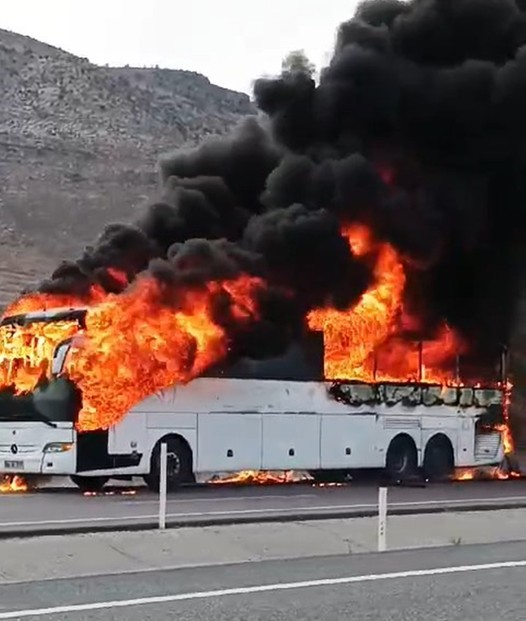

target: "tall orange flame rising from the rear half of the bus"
[307,225,462,383]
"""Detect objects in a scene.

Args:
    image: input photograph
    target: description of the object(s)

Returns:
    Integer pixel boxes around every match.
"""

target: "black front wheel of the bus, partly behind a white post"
[144,436,195,493]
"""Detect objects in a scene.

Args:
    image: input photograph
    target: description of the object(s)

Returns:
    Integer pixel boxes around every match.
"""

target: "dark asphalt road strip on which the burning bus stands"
[0,480,526,537]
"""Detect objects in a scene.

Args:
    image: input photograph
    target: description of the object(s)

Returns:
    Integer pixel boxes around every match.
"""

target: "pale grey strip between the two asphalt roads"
[0,509,526,584]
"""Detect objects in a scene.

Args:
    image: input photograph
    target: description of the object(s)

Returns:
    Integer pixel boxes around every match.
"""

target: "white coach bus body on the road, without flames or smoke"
[0,309,506,491]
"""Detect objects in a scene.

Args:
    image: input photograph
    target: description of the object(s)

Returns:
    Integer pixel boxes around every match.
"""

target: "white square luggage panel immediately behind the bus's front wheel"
[197,412,262,472]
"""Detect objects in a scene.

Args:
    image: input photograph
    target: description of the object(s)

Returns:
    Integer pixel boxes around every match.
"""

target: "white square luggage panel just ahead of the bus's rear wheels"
[321,414,385,470]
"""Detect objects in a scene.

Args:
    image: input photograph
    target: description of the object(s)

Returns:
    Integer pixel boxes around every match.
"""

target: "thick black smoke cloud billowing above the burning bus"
[31,0,526,368]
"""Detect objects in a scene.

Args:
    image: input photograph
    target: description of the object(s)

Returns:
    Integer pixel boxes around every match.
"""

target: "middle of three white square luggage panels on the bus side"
[263,413,321,470]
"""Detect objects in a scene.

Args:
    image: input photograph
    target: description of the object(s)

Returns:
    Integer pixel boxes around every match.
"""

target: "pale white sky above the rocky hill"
[0,0,364,93]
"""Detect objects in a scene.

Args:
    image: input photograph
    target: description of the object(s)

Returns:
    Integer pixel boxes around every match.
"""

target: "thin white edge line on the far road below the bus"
[0,496,526,528]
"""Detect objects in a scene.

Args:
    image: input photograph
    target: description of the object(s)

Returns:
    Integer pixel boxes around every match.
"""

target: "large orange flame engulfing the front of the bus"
[0,276,265,431]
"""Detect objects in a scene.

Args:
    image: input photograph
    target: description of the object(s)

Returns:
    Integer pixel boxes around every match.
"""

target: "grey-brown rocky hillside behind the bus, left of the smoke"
[0,30,254,306]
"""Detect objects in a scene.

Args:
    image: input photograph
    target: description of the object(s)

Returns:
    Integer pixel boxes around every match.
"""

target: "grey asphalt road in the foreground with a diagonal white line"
[0,542,526,621]
